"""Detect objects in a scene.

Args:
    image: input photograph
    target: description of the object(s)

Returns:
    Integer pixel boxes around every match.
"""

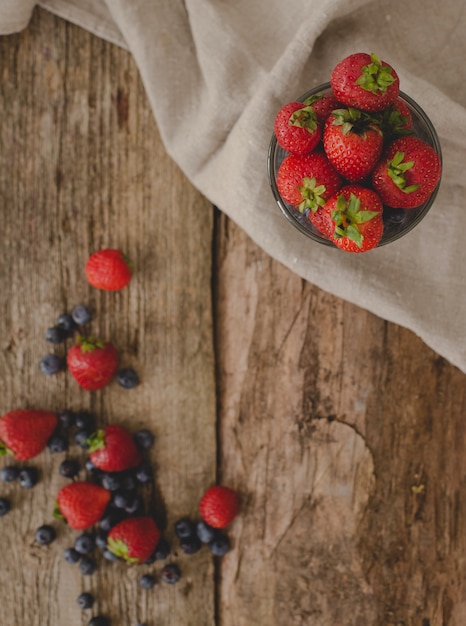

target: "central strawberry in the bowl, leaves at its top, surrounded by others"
[324,107,383,182]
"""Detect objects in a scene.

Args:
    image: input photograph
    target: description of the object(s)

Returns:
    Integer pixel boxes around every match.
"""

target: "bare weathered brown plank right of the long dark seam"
[216,216,466,626]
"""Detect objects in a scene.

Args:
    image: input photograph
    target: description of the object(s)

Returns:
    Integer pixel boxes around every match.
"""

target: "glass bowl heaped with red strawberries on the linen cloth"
[267,52,442,253]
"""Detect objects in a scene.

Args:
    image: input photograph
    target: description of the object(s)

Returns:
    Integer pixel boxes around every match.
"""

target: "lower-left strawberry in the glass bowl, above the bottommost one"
[276,152,343,213]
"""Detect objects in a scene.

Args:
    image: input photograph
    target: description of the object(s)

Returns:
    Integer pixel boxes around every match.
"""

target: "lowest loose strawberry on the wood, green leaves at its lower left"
[107,516,160,563]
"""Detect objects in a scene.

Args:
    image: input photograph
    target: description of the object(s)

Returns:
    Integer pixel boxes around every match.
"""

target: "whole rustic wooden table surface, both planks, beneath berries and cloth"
[0,9,466,626]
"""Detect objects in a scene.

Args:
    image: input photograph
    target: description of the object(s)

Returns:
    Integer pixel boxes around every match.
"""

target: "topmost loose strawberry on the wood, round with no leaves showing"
[85,248,131,291]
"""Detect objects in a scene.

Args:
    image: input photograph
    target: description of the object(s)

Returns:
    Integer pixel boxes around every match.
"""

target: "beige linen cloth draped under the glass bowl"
[0,0,466,372]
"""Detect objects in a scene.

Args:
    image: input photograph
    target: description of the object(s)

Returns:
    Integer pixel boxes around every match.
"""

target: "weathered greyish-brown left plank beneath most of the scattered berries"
[0,10,216,626]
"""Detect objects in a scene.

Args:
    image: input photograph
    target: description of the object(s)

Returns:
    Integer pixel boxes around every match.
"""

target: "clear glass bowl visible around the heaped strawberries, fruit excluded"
[267,83,442,250]
